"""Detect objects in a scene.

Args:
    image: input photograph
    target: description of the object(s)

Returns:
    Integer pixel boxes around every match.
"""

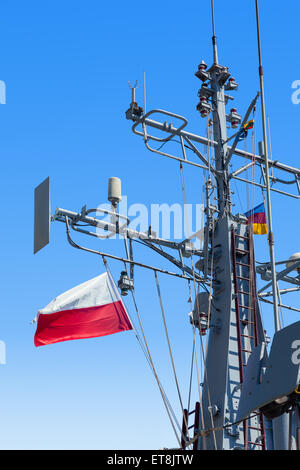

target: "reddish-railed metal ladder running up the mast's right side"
[231,226,266,450]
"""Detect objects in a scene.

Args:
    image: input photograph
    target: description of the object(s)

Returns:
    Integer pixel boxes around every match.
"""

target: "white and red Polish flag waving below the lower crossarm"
[34,273,132,346]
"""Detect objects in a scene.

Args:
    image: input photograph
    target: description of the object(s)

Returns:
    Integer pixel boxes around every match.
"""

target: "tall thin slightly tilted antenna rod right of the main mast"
[255,0,280,331]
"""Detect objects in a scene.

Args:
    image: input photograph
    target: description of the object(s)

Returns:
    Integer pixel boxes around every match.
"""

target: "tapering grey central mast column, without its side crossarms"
[199,1,263,450]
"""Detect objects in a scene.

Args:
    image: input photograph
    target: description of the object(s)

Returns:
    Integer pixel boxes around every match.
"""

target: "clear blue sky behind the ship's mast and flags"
[0,0,300,449]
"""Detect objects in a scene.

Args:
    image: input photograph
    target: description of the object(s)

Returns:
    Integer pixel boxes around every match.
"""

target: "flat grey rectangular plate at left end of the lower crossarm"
[33,177,50,254]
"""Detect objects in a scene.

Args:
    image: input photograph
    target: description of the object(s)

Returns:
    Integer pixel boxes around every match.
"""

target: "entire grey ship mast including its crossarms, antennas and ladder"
[35,0,300,450]
